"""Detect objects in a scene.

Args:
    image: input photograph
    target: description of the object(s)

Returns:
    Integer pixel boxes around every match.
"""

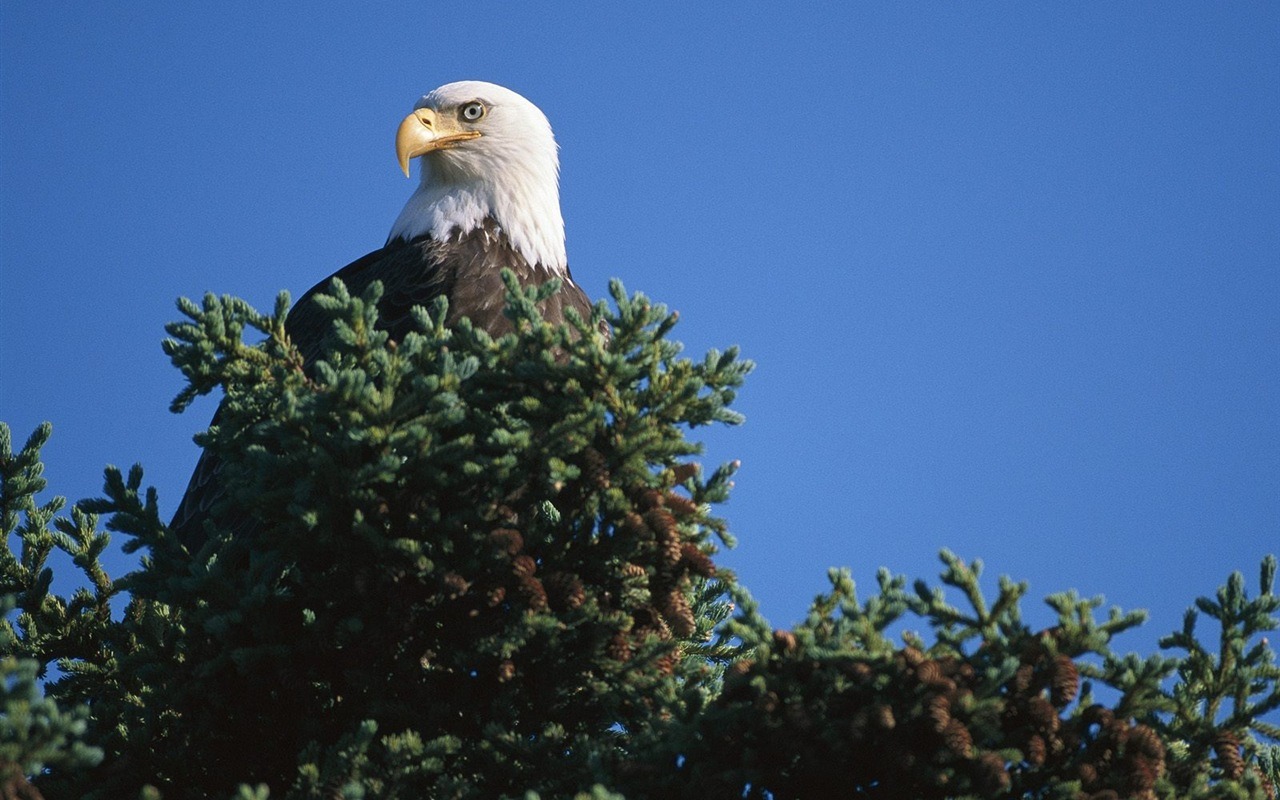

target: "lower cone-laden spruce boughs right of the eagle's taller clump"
[646,550,1280,800]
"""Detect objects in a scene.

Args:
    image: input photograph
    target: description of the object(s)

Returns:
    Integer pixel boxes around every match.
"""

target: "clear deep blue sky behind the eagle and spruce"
[0,6,1280,665]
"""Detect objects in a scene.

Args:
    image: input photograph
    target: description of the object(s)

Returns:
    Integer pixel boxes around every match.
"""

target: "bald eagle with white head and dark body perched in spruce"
[170,81,591,547]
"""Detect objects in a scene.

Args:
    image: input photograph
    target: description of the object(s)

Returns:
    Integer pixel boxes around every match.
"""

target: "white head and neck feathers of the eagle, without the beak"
[388,81,567,274]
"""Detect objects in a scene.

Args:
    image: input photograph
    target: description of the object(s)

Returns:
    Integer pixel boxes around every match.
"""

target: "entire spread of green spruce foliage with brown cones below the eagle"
[0,275,1280,800]
